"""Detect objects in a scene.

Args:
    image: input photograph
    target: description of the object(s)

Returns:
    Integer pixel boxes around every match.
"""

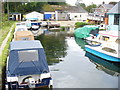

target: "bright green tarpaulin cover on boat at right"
[74,26,99,38]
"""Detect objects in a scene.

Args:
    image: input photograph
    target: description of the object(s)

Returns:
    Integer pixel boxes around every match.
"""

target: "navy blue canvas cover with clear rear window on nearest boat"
[7,40,49,76]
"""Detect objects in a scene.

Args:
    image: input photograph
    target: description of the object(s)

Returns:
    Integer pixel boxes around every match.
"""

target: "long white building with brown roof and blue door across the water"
[44,5,88,21]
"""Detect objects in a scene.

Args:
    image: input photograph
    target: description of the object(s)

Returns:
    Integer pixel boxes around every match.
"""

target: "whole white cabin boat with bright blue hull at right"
[85,31,120,62]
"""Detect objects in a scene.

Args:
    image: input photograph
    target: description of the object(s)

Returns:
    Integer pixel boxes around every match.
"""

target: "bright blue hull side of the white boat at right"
[85,46,120,62]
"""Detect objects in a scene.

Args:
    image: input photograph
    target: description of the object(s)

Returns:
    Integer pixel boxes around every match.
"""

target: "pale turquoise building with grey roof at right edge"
[107,1,120,31]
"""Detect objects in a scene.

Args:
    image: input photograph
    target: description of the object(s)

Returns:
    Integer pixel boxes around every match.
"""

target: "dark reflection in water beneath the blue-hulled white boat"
[85,52,120,76]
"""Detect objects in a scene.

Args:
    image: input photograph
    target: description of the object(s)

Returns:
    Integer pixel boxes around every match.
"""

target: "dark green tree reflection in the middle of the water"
[35,32,67,65]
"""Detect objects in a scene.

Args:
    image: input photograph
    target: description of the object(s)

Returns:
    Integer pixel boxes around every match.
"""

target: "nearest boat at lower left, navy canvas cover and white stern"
[6,40,52,90]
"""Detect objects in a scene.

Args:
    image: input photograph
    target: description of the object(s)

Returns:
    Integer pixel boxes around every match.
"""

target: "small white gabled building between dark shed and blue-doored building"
[25,11,44,21]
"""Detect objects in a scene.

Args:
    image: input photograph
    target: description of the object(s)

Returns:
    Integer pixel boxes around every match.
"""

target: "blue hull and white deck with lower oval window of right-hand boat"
[85,45,120,62]
